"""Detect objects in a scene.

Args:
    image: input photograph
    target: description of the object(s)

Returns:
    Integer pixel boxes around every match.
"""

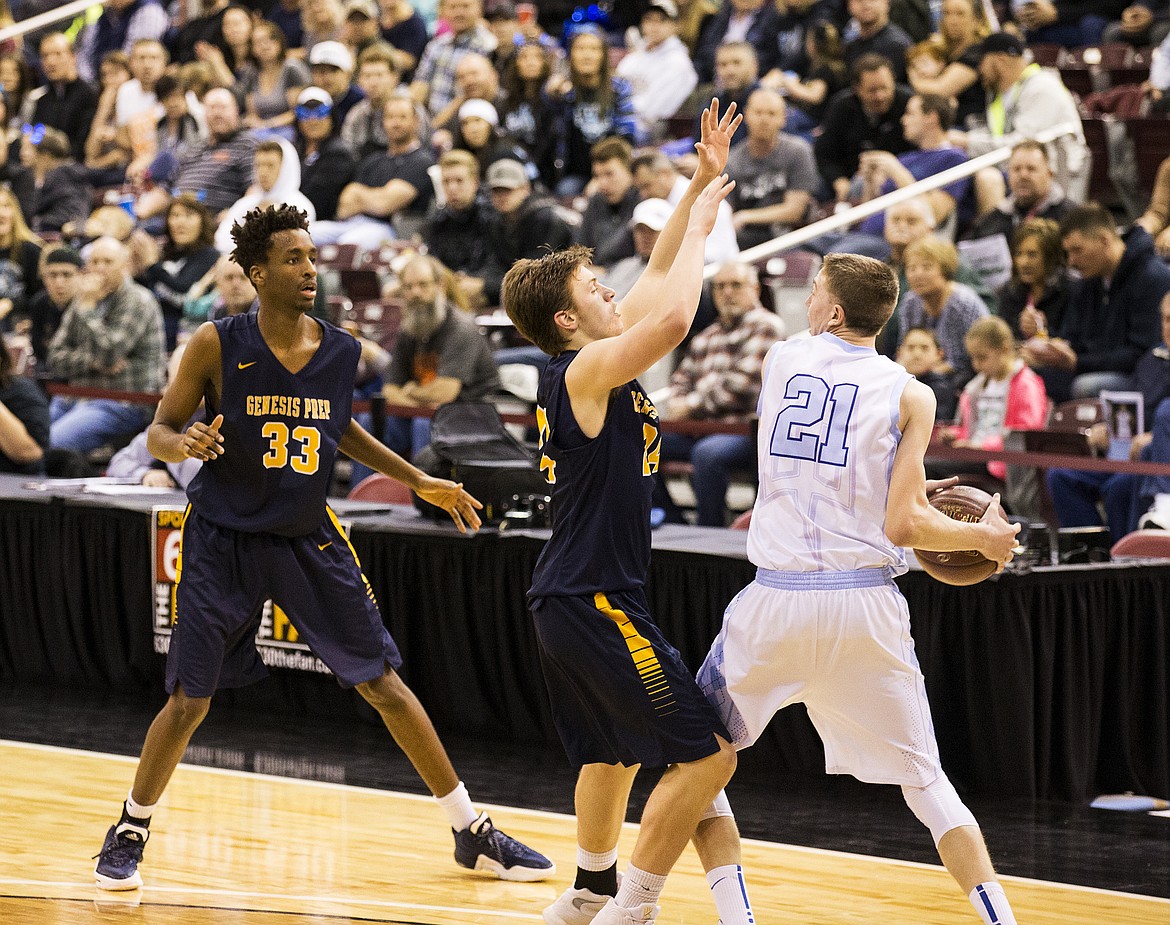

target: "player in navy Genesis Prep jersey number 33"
[95,206,556,890]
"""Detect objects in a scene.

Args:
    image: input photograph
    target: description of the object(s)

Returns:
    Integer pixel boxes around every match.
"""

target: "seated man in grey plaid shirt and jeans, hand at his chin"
[48,237,166,453]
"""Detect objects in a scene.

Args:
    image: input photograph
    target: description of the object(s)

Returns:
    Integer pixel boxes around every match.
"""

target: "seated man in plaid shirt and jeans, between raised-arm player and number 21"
[659,262,785,526]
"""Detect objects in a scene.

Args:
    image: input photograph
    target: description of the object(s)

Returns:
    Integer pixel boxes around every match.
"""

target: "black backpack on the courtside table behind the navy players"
[414,401,552,527]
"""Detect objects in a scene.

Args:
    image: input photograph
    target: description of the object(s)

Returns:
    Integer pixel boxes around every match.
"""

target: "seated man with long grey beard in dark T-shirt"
[383,256,500,456]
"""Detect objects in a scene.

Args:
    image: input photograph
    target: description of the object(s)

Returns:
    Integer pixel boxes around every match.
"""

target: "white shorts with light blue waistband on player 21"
[698,568,941,787]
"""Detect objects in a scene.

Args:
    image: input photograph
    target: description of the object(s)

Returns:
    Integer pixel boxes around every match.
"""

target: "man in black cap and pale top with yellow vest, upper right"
[949,32,1092,202]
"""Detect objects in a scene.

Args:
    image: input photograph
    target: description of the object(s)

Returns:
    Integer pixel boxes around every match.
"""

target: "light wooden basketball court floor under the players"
[0,740,1170,925]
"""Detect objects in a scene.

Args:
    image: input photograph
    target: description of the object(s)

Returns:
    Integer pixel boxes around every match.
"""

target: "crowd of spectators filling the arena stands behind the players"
[0,0,1170,535]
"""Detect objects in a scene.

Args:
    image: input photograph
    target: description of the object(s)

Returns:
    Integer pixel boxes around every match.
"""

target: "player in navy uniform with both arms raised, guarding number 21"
[503,101,751,925]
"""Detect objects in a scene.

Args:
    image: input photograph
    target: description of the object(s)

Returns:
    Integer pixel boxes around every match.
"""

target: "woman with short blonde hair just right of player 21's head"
[899,235,990,388]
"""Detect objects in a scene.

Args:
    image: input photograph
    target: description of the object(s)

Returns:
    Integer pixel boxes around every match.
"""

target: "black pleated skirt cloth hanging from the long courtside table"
[0,497,1170,800]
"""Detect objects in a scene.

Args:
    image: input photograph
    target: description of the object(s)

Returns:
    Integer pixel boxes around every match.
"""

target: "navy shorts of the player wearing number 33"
[166,508,402,697]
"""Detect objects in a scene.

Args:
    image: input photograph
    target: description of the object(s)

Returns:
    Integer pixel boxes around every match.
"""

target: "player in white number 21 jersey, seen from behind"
[698,254,1019,925]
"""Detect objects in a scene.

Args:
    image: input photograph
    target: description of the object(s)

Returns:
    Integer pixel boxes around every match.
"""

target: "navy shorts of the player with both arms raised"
[529,591,731,768]
